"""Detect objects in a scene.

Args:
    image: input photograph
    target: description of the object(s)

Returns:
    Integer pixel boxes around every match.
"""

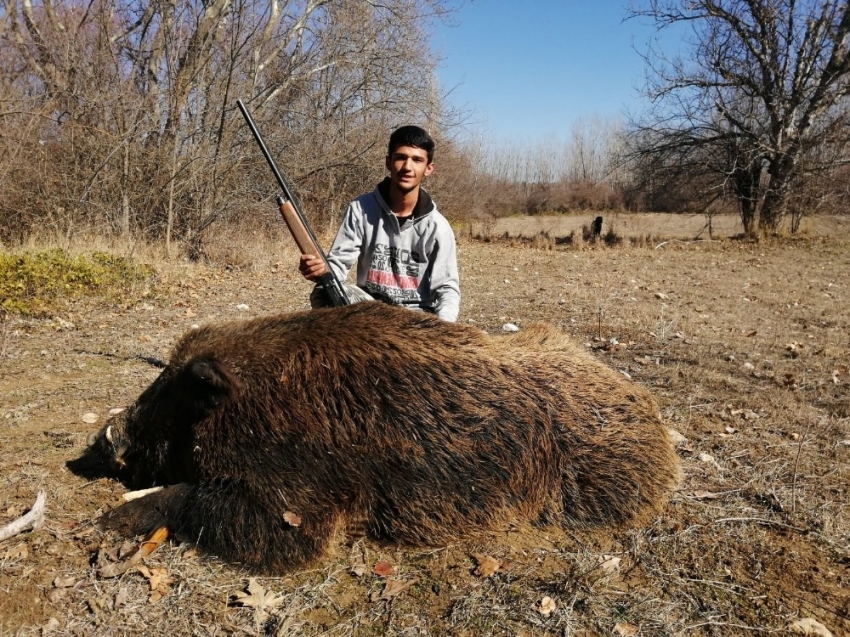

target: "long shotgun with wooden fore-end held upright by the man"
[236,100,351,307]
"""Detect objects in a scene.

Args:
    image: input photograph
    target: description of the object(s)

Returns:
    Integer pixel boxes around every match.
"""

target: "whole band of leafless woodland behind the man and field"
[0,0,850,259]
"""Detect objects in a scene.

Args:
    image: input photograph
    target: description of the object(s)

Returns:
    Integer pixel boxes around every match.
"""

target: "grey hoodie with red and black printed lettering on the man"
[328,179,460,321]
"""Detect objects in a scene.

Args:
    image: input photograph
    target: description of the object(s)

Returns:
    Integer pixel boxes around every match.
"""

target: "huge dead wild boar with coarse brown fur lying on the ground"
[69,303,679,572]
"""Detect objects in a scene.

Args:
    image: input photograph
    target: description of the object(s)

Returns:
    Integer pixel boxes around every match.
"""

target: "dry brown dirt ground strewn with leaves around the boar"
[0,231,850,636]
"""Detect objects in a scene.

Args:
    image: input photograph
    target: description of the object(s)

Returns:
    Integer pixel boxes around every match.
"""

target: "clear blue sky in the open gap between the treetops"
[434,0,671,141]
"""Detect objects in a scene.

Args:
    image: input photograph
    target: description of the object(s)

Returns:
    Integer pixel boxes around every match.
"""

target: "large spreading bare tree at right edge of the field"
[632,0,850,235]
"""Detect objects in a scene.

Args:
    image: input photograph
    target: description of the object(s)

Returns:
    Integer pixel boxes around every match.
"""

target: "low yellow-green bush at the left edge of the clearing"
[0,249,155,316]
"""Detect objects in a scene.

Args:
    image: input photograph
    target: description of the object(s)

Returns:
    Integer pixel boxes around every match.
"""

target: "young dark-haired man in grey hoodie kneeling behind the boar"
[298,126,460,321]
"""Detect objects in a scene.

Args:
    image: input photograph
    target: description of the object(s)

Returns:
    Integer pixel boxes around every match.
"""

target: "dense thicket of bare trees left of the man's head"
[0,0,453,244]
